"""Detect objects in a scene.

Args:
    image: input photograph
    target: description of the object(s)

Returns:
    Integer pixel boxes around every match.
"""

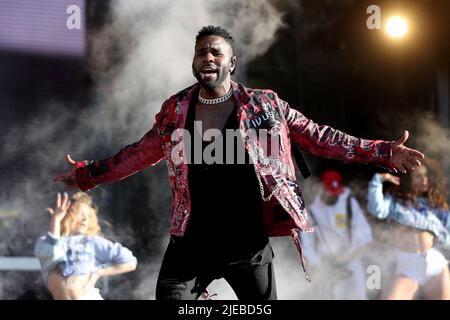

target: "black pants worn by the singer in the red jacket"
[156,237,277,300]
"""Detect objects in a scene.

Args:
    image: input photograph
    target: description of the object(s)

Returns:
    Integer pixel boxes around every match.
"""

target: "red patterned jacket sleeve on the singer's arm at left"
[76,104,165,191]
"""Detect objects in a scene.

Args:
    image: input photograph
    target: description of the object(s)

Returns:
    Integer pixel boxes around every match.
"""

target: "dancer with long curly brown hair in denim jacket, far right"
[368,159,450,299]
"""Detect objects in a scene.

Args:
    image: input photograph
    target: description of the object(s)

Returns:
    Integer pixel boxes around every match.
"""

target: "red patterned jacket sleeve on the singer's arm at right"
[279,99,393,169]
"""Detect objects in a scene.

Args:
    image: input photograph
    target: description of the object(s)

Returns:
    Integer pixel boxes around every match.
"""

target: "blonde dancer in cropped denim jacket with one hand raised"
[35,192,137,300]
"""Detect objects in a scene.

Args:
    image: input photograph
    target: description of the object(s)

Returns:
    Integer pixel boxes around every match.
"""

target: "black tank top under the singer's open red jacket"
[184,95,269,263]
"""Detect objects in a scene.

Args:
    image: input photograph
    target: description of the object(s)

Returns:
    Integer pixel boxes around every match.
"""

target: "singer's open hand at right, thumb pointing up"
[392,131,425,173]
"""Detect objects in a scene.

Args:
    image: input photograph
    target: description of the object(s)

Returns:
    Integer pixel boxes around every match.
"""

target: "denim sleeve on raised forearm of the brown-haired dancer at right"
[367,173,393,219]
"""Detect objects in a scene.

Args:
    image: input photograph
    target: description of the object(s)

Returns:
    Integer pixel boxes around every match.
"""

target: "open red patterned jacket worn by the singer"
[76,82,393,278]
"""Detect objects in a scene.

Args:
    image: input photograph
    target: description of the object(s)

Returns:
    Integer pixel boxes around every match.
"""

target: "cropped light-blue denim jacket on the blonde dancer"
[34,232,137,284]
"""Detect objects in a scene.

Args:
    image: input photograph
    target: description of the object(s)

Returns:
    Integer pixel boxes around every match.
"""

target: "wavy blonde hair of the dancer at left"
[61,191,101,236]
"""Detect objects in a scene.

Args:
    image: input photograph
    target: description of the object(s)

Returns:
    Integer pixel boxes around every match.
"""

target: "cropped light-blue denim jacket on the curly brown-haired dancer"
[368,174,450,247]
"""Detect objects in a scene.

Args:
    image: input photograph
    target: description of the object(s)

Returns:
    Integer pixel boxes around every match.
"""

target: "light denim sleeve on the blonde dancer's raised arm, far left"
[34,232,66,273]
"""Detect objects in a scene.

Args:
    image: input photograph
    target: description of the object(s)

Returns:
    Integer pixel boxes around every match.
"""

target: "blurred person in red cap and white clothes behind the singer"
[302,170,373,300]
